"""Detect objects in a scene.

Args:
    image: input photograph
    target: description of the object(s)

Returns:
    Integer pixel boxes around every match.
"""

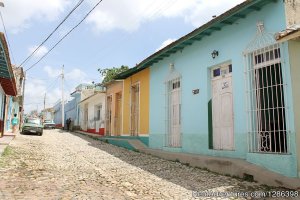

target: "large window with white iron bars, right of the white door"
[245,44,289,153]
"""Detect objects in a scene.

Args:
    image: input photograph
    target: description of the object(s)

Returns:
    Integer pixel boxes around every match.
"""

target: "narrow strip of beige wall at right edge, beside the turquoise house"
[289,40,300,177]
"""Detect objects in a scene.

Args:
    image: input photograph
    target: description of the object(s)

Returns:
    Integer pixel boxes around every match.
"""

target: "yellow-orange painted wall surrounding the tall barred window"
[123,68,150,136]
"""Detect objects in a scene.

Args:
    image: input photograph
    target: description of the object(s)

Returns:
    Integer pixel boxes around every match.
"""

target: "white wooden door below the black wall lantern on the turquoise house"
[212,67,234,150]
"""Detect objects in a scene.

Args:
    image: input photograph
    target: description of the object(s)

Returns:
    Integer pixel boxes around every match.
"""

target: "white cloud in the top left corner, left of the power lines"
[0,0,71,33]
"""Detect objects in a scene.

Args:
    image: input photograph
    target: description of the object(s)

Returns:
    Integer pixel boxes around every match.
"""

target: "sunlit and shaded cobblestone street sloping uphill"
[0,130,294,200]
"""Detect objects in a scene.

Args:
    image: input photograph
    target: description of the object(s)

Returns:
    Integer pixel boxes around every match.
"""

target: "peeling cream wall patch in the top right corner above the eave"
[284,0,300,27]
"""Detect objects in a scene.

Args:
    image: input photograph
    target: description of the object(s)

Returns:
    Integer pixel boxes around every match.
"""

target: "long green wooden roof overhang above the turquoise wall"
[116,0,278,79]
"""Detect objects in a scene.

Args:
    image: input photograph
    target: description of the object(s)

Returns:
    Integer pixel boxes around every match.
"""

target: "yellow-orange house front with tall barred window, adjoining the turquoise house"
[117,68,150,136]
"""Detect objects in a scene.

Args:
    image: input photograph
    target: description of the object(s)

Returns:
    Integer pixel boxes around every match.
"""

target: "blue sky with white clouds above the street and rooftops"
[0,0,243,113]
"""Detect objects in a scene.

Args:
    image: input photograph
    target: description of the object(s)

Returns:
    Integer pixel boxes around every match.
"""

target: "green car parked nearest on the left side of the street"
[21,118,43,136]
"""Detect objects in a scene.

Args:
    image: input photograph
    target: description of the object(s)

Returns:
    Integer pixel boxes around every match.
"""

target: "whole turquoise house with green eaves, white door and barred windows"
[137,0,300,177]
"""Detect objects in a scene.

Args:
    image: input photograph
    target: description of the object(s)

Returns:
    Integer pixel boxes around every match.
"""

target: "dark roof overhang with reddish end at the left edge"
[0,32,17,96]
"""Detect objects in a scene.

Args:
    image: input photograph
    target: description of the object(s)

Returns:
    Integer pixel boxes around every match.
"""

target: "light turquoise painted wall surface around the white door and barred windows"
[149,1,297,177]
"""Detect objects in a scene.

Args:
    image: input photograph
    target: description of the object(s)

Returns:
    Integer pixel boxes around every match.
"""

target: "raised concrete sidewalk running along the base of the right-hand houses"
[75,131,300,190]
